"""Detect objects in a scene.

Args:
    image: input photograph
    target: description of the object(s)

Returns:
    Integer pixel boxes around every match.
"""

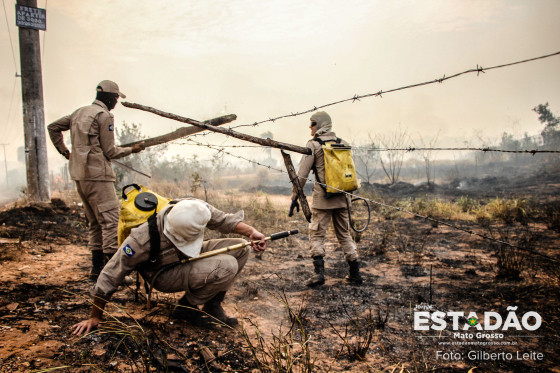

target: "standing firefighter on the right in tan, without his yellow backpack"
[289,111,363,287]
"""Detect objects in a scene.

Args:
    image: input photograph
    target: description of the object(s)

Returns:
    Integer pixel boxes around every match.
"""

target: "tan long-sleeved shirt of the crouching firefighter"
[90,199,244,300]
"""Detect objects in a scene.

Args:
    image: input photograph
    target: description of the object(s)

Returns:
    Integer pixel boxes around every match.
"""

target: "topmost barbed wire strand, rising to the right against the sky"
[187,51,560,137]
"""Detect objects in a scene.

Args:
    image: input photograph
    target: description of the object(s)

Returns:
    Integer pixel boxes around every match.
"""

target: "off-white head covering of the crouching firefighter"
[163,200,212,258]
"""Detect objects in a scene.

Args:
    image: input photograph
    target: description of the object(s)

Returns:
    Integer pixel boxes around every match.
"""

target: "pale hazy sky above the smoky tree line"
[0,0,560,180]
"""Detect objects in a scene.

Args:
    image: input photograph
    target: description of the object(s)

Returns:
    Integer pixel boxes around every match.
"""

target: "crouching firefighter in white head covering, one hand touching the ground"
[73,199,267,335]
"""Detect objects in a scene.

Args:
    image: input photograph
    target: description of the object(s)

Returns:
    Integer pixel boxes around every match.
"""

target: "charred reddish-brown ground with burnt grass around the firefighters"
[0,186,560,372]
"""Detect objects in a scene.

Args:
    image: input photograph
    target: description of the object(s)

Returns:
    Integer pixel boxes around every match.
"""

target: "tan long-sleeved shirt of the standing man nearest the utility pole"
[47,100,132,181]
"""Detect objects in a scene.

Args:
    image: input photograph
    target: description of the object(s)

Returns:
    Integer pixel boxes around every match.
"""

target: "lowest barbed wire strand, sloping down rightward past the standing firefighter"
[183,138,558,262]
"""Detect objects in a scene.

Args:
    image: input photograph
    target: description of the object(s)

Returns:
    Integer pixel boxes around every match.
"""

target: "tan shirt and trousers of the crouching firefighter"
[90,204,250,305]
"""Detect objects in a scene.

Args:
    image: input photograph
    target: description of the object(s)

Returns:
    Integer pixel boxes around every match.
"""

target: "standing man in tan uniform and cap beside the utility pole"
[48,80,144,281]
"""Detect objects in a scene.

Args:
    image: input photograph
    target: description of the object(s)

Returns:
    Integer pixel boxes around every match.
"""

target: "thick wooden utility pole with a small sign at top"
[16,0,50,202]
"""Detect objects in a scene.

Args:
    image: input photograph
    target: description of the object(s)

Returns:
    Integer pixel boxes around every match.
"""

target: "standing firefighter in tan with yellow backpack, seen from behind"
[289,111,363,287]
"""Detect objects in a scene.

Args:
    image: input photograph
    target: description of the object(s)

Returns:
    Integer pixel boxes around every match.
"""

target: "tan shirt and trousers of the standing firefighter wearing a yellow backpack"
[292,129,358,261]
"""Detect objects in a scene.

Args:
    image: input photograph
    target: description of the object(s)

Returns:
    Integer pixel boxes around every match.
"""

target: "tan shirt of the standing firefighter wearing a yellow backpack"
[292,132,348,209]
